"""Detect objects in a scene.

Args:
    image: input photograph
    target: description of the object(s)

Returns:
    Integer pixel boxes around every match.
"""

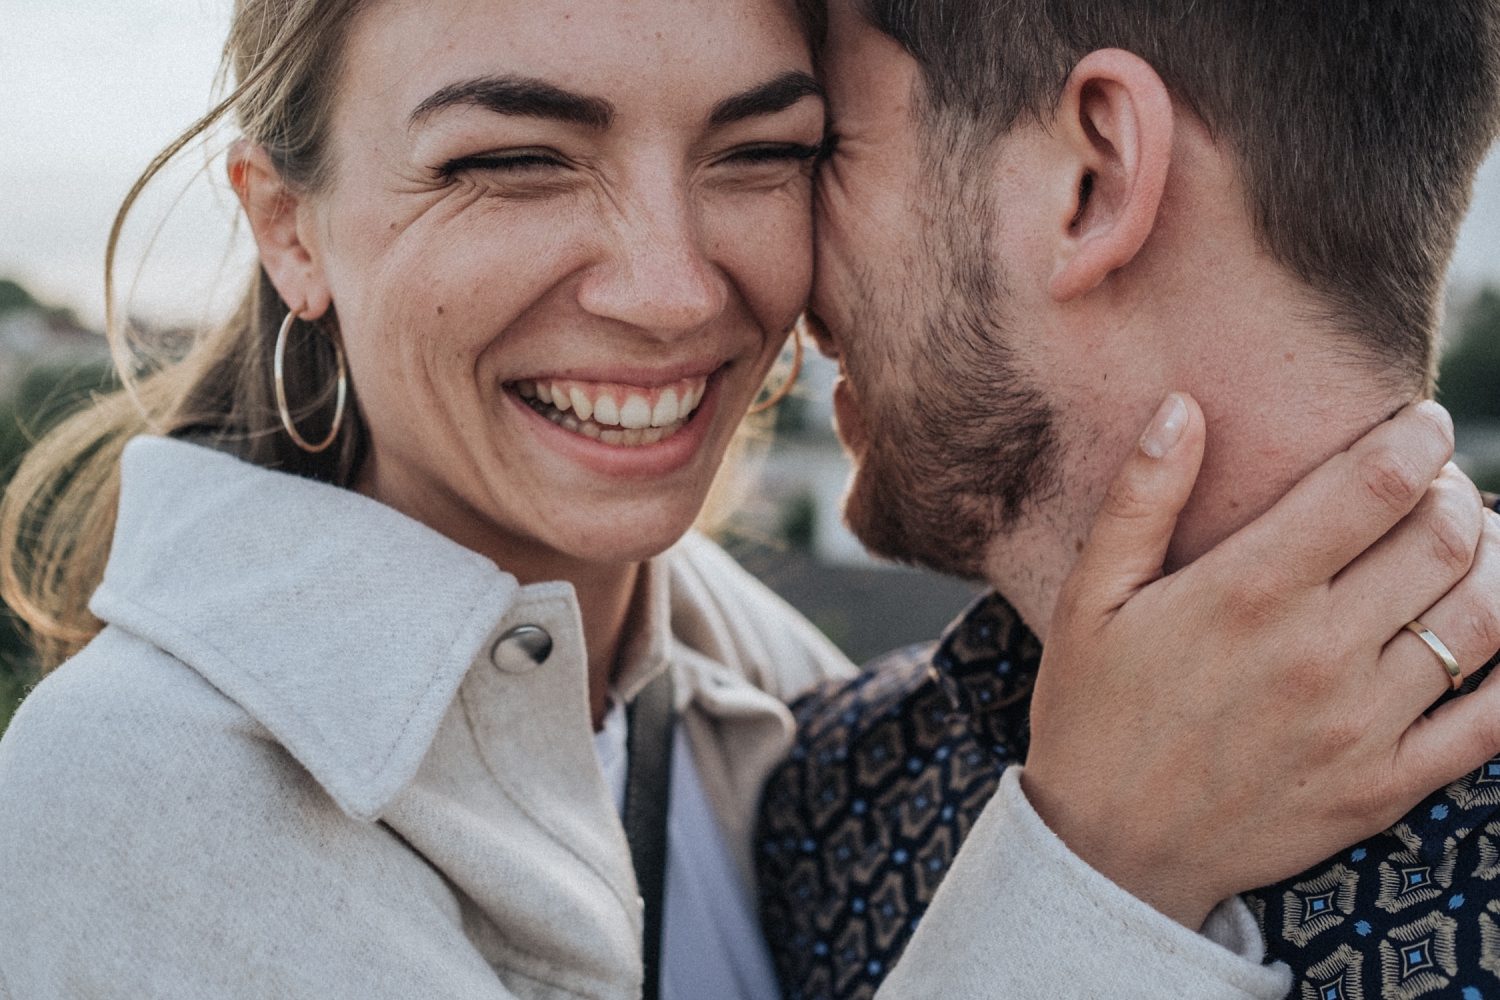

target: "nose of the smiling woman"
[578,185,729,339]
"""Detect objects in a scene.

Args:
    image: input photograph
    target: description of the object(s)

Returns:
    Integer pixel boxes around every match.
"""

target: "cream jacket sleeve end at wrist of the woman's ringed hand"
[876,768,1292,1000]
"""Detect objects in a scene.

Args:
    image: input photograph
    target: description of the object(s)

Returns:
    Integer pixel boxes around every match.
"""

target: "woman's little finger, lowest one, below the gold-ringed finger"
[1392,659,1500,802]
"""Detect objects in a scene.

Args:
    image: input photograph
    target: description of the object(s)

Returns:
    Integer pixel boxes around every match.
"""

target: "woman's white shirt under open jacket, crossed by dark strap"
[594,699,782,1000]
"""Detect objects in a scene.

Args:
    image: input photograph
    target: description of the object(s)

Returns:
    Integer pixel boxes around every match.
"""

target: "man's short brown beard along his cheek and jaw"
[845,168,1062,579]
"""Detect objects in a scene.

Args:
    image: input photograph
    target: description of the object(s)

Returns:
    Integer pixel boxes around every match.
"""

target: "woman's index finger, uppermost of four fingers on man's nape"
[1208,402,1454,591]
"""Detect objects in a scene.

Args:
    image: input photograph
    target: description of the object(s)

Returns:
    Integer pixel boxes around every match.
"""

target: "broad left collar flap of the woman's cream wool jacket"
[90,438,534,820]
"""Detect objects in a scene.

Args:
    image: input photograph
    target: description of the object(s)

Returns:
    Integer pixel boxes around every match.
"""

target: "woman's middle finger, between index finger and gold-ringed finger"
[1329,463,1485,643]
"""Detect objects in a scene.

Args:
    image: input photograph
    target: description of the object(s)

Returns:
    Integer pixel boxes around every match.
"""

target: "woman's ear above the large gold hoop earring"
[228,139,333,319]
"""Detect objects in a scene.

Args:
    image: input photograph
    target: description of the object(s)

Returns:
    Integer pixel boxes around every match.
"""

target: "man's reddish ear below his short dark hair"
[1047,48,1175,301]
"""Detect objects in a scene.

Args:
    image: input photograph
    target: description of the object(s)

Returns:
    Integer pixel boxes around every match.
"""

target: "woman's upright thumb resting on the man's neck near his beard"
[1065,393,1203,615]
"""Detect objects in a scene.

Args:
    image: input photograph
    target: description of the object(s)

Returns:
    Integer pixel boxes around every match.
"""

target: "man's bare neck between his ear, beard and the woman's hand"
[986,109,1421,639]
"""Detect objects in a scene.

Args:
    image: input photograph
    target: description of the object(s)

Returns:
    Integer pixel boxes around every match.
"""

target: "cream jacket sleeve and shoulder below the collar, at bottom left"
[0,641,525,1000]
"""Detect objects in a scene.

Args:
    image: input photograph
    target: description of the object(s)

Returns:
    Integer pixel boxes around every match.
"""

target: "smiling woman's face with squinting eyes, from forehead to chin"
[278,0,824,565]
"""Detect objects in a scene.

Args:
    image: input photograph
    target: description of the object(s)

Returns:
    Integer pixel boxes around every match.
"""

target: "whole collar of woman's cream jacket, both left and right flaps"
[90,438,822,839]
